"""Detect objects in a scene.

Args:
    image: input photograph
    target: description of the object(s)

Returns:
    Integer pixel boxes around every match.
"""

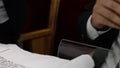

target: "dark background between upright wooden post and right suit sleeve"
[55,0,92,52]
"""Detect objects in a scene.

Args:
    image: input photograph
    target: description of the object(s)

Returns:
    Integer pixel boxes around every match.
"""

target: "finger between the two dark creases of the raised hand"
[95,6,120,27]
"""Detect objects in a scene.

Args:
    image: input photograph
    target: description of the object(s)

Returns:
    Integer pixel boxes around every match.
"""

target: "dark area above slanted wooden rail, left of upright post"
[22,0,51,33]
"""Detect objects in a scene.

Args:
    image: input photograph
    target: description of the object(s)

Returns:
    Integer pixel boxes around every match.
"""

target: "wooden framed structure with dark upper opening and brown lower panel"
[20,0,59,54]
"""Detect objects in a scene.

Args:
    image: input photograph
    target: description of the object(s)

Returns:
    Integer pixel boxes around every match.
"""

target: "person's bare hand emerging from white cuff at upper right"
[91,0,120,29]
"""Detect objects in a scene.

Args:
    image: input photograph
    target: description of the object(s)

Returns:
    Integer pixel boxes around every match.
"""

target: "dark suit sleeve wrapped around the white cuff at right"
[78,1,118,48]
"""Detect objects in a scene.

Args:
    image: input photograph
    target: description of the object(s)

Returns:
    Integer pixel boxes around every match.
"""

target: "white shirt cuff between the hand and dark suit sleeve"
[87,15,111,40]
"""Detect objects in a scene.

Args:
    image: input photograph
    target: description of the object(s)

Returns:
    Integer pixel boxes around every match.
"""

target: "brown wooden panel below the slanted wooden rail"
[31,36,52,54]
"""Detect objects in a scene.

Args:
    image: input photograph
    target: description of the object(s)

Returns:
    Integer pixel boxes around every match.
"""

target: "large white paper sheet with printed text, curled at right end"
[0,44,94,68]
